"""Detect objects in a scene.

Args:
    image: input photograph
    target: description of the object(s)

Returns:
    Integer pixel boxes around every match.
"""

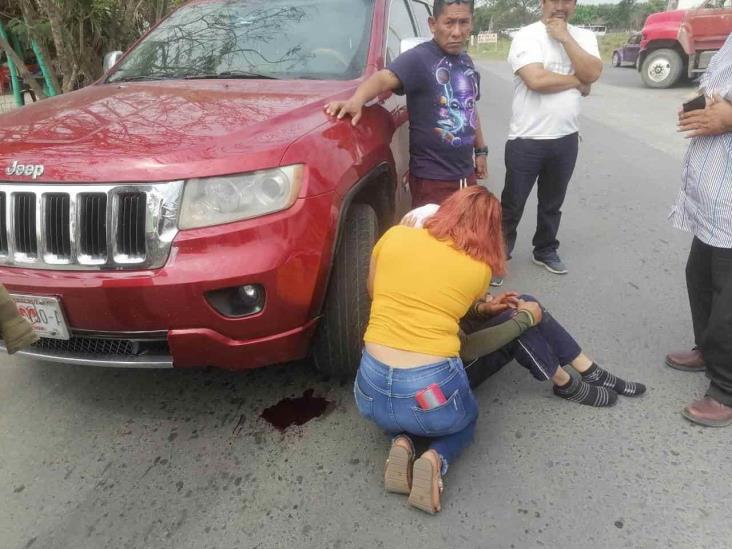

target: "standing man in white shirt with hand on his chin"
[491,0,602,285]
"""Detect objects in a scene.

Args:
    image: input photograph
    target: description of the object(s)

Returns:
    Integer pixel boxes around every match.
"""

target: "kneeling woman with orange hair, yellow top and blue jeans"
[354,186,541,513]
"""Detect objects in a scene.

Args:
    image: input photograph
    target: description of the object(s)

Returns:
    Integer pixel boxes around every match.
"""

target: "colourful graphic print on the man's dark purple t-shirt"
[434,57,479,147]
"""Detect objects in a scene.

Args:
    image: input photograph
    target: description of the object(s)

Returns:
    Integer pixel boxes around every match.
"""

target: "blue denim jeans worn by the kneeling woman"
[353,350,478,475]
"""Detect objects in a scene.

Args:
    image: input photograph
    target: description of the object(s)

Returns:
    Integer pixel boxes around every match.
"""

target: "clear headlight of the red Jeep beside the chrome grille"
[178,164,304,229]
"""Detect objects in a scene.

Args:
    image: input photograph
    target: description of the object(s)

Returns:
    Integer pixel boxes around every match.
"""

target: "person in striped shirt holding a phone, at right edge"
[666,35,732,427]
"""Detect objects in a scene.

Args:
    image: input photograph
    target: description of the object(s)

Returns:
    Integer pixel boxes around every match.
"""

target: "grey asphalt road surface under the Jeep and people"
[0,63,732,549]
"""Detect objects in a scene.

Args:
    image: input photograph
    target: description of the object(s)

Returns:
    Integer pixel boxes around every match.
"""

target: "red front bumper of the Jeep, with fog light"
[0,194,336,369]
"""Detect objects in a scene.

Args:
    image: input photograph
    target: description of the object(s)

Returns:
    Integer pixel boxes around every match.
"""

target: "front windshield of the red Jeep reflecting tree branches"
[107,0,374,82]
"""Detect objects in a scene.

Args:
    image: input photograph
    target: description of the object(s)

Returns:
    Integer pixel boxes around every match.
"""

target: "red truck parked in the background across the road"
[637,0,732,88]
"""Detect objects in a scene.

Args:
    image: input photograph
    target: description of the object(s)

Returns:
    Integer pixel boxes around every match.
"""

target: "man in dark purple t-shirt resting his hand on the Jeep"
[325,0,488,207]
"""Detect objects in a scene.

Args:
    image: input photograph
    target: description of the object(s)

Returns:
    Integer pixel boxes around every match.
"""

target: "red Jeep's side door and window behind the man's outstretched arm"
[379,0,417,219]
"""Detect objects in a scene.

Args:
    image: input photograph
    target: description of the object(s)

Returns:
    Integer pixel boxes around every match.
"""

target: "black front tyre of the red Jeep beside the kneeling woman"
[313,204,378,377]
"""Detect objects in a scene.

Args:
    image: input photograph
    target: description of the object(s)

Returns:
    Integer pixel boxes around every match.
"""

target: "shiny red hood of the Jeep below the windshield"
[0,80,355,183]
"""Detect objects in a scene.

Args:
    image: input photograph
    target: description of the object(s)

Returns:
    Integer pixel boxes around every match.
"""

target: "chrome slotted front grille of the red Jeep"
[0,181,183,270]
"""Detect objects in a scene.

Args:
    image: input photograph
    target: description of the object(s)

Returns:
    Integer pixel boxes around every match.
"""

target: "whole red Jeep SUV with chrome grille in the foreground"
[0,0,430,374]
